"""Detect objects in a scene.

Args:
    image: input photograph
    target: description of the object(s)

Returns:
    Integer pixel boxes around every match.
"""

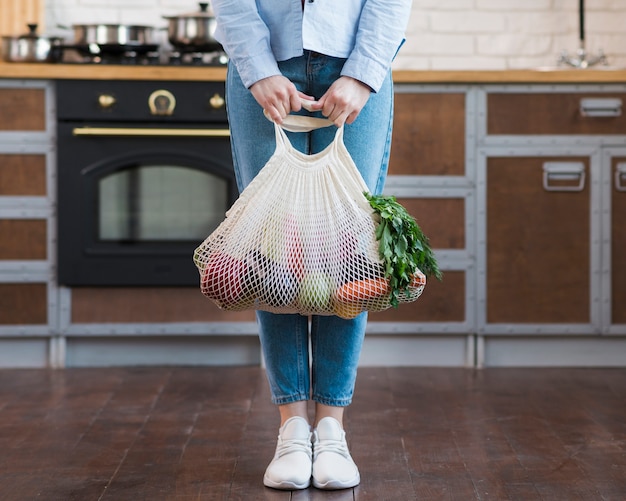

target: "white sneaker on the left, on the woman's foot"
[263,417,312,490]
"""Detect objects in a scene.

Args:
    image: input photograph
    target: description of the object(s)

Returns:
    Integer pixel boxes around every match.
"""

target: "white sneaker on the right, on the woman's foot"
[313,417,361,489]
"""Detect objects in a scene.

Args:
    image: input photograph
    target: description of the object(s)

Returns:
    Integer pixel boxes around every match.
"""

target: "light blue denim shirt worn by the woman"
[211,0,412,92]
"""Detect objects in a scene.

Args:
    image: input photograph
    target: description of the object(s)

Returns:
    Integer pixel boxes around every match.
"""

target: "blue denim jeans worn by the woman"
[226,52,393,407]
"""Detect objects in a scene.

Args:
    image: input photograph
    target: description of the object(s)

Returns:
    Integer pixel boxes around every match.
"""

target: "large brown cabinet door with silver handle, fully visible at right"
[486,157,591,324]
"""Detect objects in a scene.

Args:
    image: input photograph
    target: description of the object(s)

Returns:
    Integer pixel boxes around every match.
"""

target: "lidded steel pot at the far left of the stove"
[2,24,63,63]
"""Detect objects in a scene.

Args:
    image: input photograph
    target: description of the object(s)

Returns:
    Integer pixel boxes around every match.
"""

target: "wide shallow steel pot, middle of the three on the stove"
[72,24,154,46]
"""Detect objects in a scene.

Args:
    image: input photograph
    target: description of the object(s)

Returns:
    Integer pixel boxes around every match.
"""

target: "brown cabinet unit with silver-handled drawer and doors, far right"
[477,86,626,342]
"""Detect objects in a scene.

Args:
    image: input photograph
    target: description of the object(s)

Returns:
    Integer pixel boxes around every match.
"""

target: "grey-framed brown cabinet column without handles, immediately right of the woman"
[362,88,475,365]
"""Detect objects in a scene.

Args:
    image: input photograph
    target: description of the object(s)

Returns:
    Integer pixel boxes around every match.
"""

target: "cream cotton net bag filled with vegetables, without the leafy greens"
[194,107,426,318]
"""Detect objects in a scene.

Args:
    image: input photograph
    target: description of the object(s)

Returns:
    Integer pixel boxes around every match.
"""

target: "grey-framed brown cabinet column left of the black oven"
[0,81,54,366]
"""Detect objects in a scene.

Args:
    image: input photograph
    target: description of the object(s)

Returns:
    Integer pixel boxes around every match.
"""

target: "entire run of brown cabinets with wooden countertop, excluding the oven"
[0,63,626,367]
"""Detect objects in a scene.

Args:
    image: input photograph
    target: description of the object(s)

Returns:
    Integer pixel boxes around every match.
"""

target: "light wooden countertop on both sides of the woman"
[0,62,626,84]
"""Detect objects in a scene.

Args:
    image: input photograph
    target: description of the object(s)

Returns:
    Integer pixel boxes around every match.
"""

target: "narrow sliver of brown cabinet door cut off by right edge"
[611,157,626,324]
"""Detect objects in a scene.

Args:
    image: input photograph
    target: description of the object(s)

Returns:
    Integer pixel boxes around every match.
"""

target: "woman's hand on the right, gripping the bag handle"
[313,76,372,127]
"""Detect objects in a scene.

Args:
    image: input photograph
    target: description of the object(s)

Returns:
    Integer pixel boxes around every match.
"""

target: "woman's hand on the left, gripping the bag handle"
[250,75,315,124]
